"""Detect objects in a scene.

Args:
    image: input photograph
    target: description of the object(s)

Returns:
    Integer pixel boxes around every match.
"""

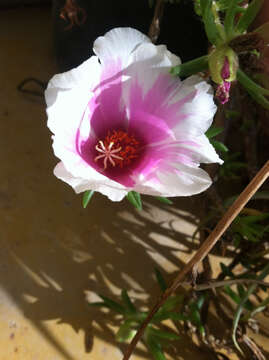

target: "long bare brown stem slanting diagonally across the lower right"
[123,160,269,360]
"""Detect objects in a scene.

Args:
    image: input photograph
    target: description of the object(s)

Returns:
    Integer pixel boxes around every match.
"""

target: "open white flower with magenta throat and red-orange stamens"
[45,28,222,201]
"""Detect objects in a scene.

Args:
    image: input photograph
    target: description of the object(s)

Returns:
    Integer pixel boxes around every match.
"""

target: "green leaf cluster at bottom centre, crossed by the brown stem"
[90,269,205,360]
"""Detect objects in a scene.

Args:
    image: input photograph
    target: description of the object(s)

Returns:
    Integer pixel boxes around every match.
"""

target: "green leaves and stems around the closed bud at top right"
[171,0,269,109]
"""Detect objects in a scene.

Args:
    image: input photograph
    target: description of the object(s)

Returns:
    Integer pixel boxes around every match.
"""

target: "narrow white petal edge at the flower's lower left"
[54,162,127,201]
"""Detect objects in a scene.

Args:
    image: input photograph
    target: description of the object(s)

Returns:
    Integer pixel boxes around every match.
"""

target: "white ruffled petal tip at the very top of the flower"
[93,28,150,67]
